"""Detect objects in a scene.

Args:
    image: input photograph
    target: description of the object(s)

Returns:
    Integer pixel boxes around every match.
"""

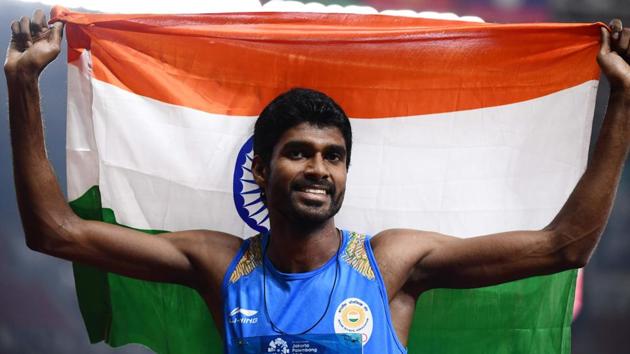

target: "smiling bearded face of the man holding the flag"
[254,122,348,225]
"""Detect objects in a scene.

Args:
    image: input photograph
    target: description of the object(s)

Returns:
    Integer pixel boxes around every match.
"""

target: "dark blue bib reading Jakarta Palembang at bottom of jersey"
[228,333,363,354]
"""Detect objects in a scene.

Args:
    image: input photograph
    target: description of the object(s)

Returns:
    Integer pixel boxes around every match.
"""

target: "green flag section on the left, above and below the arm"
[70,186,223,354]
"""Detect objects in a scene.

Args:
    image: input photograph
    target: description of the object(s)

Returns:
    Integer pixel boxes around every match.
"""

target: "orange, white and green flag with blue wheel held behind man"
[55,8,601,354]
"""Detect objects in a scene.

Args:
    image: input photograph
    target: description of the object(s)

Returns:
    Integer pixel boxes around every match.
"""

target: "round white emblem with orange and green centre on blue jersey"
[334,297,374,345]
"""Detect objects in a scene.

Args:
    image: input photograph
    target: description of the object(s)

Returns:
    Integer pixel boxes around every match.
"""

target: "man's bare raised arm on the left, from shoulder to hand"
[4,10,240,295]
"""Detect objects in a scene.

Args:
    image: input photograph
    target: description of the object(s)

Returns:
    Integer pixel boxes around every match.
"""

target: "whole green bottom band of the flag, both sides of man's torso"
[70,187,576,354]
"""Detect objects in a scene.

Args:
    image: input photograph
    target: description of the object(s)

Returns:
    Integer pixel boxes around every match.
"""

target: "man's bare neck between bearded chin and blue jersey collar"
[267,218,341,273]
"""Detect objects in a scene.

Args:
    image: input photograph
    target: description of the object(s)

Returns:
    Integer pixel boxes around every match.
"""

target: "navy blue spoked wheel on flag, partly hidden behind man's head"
[233,136,269,233]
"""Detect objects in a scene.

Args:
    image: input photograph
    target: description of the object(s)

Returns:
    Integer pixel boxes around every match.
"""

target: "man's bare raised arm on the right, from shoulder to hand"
[372,20,630,299]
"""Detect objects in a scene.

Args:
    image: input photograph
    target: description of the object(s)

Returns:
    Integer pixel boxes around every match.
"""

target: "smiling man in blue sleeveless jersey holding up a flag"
[5,11,630,353]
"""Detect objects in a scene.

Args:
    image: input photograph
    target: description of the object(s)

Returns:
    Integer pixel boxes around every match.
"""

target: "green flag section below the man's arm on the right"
[409,270,577,354]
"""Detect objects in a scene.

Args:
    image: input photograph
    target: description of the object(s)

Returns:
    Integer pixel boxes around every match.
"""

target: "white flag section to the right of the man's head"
[348,81,598,237]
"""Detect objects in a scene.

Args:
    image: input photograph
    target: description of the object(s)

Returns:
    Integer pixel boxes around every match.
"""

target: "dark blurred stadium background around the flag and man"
[0,0,630,354]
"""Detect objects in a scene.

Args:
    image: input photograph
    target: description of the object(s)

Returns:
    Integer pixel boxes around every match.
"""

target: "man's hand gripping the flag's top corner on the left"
[4,10,63,79]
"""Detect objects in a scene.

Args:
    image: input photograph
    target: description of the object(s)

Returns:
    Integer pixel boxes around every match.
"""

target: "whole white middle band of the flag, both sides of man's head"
[68,52,597,236]
